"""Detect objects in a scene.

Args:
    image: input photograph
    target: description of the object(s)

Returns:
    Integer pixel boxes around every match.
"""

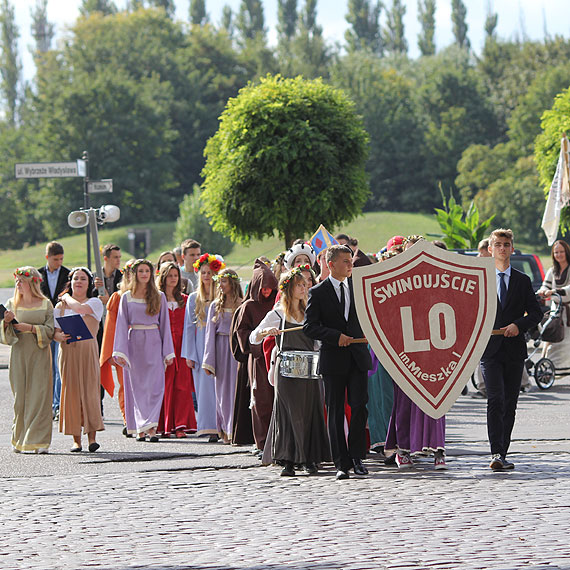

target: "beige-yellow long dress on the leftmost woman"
[0,299,54,451]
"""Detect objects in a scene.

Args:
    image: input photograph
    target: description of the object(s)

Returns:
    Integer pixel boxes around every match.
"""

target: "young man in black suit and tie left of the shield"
[303,245,372,480]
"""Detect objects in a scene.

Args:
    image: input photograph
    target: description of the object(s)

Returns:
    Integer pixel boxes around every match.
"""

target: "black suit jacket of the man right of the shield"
[482,266,542,360]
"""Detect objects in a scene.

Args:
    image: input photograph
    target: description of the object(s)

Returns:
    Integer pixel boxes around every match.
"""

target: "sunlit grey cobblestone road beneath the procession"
[0,344,570,570]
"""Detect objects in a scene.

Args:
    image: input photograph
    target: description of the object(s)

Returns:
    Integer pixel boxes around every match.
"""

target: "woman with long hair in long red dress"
[156,262,196,438]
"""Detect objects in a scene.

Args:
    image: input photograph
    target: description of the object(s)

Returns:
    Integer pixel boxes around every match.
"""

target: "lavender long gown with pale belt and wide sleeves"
[113,291,175,433]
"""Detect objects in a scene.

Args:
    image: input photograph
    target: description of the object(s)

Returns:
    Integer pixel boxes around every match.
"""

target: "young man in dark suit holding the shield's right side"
[481,229,542,471]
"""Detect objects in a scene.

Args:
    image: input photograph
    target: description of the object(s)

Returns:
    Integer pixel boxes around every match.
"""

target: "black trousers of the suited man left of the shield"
[323,363,368,471]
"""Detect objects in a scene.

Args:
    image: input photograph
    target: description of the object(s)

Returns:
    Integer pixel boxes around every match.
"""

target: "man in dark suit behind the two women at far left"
[38,241,69,419]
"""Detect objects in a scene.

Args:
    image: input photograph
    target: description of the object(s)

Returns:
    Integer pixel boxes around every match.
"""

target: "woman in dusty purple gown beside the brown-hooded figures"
[202,269,243,443]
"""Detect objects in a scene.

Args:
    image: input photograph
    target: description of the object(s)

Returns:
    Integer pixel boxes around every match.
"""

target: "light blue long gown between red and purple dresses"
[180,293,218,435]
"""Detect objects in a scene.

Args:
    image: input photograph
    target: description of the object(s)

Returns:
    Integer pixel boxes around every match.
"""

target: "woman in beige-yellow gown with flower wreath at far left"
[0,267,54,453]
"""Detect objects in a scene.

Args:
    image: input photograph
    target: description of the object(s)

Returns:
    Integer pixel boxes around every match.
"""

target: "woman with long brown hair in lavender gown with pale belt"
[113,259,174,442]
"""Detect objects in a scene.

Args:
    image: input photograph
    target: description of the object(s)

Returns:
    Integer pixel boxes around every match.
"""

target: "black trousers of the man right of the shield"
[481,353,524,457]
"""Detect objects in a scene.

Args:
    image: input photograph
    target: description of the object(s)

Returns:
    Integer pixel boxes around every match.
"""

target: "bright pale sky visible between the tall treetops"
[12,0,570,80]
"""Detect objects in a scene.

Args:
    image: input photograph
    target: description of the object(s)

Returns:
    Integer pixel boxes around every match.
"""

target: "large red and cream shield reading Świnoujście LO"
[352,241,497,419]
